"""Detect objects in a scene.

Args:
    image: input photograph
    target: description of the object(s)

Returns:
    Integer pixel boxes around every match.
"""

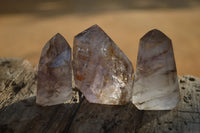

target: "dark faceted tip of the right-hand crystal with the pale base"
[140,29,170,42]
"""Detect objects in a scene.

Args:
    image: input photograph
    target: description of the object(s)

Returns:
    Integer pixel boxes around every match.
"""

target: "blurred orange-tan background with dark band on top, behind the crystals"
[0,0,200,77]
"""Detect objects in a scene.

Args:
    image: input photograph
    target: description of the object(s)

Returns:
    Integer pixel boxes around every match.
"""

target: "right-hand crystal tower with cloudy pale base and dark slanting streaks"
[132,30,179,110]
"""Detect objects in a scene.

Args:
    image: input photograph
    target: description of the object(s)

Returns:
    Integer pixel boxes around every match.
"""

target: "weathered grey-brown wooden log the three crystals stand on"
[0,58,200,133]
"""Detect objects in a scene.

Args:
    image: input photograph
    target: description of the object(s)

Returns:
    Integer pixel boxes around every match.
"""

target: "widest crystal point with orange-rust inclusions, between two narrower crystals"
[73,25,133,105]
